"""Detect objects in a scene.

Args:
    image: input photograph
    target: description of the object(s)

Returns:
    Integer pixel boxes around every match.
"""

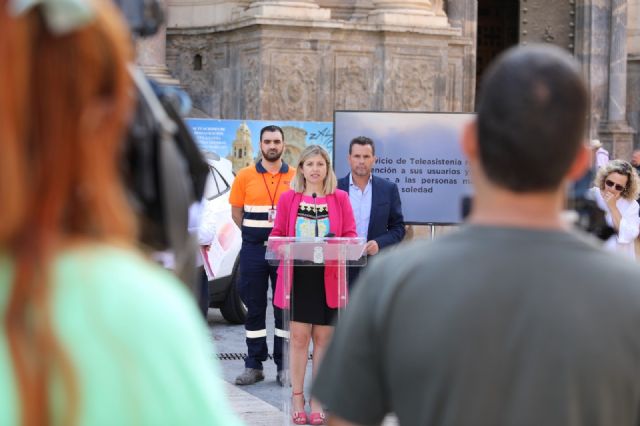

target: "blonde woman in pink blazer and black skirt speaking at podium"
[271,145,357,425]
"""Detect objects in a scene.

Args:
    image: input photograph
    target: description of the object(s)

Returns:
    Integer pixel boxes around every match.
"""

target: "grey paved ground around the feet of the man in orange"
[208,302,398,426]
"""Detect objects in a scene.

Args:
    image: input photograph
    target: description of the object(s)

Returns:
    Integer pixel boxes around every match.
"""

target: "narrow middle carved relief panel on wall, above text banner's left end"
[334,56,372,110]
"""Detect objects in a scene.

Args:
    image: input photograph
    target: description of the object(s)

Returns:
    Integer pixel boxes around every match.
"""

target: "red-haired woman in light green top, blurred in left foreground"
[0,0,237,426]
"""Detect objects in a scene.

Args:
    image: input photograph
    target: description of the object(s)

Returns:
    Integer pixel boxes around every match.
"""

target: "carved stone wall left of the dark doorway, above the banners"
[167,0,474,121]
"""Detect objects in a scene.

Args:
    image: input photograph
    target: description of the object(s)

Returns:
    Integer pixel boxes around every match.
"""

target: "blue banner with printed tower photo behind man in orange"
[186,118,333,172]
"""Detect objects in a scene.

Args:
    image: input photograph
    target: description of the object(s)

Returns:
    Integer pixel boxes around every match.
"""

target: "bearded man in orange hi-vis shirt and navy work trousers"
[229,126,295,386]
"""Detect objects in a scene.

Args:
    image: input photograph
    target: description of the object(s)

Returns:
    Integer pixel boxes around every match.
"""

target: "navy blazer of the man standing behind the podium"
[338,175,405,285]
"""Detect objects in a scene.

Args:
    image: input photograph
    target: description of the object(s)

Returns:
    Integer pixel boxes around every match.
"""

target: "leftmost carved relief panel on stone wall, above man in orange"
[265,52,319,120]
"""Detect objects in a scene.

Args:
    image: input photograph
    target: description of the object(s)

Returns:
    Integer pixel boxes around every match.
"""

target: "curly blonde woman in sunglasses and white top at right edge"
[591,160,640,259]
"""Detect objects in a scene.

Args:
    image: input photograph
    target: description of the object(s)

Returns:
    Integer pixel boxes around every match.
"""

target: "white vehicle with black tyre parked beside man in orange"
[203,152,247,324]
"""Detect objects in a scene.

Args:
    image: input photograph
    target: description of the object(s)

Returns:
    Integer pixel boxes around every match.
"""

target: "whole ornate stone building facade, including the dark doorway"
[141,0,640,158]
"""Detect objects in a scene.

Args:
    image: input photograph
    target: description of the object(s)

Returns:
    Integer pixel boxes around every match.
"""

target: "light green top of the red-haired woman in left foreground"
[0,246,239,426]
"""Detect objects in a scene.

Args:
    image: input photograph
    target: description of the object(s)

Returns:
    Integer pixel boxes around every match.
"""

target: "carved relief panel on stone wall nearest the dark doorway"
[390,58,438,111]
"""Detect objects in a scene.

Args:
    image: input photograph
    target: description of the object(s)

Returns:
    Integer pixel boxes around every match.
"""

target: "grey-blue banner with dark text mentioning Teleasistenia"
[334,111,474,224]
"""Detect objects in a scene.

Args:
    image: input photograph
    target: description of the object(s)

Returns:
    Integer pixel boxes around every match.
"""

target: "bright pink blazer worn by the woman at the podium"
[271,189,358,308]
